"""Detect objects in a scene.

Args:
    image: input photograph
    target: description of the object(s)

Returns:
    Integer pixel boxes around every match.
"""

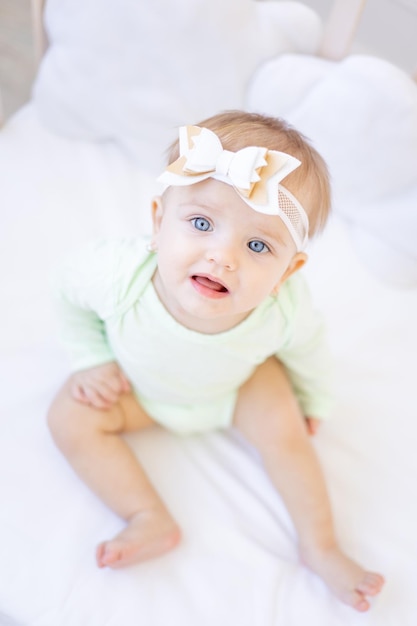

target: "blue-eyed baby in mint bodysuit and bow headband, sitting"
[48,111,384,611]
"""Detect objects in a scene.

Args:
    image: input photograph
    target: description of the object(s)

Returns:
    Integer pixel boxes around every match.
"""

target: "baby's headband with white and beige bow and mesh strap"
[158,126,308,251]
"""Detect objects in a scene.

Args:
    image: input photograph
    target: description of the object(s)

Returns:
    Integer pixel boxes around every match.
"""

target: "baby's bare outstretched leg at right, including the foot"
[234,358,384,611]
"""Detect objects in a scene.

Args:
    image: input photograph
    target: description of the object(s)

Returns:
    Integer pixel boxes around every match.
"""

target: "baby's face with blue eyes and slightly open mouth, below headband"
[153,179,306,333]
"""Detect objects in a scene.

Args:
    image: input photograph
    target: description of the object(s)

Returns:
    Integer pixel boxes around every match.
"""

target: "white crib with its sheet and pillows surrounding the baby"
[0,0,417,626]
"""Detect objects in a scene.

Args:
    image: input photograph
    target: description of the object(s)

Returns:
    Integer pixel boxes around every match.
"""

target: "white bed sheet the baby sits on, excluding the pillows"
[0,105,417,626]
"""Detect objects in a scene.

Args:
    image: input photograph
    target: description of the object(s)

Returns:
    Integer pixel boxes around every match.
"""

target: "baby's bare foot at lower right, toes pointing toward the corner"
[302,547,385,612]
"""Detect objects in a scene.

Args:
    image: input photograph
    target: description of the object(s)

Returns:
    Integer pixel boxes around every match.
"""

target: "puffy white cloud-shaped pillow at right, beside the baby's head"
[247,54,417,288]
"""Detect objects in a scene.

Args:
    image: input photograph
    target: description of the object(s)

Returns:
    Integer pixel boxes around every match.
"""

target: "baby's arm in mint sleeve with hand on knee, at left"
[54,239,154,409]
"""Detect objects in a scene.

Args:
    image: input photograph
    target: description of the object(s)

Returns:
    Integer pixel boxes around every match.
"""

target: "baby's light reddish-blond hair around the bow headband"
[168,111,331,237]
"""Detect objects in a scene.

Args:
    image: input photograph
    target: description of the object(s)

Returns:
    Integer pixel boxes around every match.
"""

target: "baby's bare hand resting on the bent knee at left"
[70,362,131,409]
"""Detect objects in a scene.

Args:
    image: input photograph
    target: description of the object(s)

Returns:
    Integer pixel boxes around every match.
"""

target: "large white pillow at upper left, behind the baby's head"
[34,0,321,174]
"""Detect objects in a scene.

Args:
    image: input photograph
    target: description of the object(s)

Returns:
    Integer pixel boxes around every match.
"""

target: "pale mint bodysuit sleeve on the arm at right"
[276,274,333,419]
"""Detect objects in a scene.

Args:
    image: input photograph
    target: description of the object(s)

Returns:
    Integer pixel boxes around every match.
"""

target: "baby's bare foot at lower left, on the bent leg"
[96,507,181,568]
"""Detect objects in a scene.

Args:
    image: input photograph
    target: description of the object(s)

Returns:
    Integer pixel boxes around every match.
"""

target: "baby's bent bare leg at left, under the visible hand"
[48,384,180,567]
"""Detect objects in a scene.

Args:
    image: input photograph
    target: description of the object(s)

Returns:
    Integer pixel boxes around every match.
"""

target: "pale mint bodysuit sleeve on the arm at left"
[54,240,150,370]
